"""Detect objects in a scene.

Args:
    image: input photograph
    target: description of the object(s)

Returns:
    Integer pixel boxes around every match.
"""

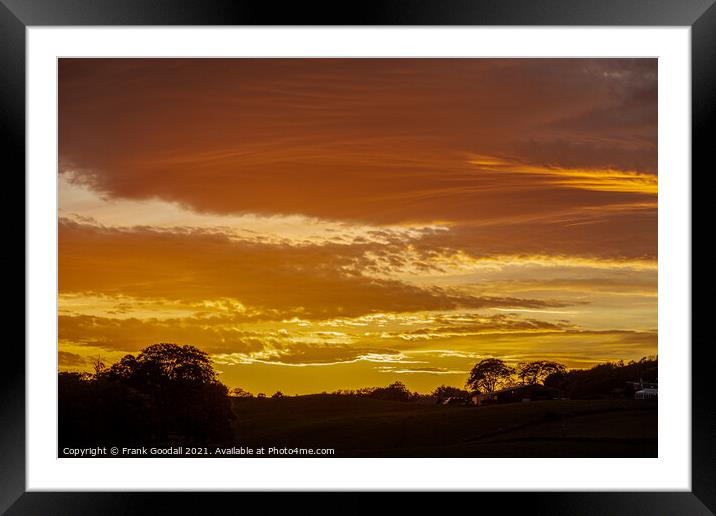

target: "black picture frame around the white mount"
[0,0,716,515]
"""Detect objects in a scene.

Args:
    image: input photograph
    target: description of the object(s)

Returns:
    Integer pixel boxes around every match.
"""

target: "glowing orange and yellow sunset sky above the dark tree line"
[58,59,658,394]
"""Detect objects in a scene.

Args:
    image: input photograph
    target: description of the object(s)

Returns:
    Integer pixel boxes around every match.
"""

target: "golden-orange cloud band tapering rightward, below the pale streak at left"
[59,220,563,320]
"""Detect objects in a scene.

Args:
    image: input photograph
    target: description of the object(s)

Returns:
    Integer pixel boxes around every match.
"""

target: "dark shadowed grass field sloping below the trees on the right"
[233,395,657,457]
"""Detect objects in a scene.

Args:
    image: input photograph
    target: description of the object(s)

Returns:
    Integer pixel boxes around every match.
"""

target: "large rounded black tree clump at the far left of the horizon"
[59,344,233,445]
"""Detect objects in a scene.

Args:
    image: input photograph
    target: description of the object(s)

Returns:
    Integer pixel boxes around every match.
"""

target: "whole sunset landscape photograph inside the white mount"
[56,58,658,460]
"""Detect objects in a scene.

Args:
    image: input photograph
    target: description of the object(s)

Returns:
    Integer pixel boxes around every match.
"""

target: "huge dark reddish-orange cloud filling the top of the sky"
[59,59,656,228]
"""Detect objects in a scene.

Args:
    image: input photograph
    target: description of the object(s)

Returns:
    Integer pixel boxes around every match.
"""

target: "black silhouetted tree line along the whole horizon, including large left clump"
[58,344,658,446]
